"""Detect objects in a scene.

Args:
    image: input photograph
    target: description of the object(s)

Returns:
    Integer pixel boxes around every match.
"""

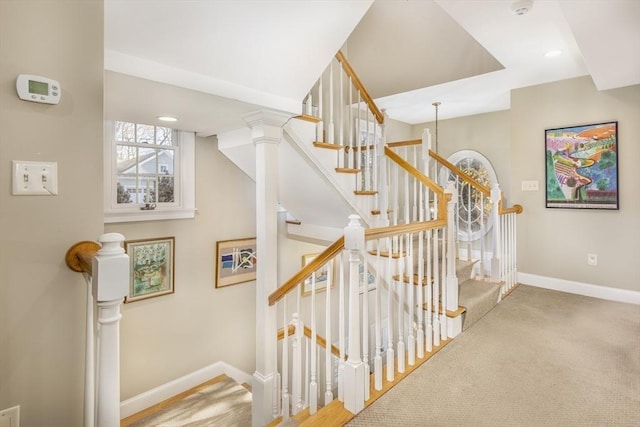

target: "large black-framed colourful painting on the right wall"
[544,121,619,210]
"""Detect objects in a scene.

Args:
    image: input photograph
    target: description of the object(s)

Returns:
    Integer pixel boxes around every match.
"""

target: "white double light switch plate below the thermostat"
[11,160,58,196]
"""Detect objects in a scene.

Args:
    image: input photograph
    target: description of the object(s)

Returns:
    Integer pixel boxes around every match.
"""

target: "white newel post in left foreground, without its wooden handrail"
[92,233,129,427]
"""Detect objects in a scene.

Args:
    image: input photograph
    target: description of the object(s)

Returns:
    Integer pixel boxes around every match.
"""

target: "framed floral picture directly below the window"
[124,237,175,303]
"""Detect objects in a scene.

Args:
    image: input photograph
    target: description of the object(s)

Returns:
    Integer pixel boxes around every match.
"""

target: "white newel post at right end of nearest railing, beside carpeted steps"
[446,181,462,338]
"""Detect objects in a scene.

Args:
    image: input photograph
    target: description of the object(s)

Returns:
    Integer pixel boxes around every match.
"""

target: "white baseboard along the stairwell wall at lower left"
[120,362,252,419]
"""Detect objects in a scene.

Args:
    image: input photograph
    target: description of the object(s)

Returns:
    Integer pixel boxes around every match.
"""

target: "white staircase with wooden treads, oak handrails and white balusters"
[219,53,522,425]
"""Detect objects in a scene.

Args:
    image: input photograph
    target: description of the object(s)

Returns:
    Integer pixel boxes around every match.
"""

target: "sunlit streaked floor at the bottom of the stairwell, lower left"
[130,378,251,427]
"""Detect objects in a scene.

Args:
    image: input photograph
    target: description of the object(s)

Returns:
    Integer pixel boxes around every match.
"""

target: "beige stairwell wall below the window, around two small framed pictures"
[105,137,256,400]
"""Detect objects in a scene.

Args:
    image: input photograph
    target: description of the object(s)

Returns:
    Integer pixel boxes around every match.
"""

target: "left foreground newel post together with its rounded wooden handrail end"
[65,233,129,427]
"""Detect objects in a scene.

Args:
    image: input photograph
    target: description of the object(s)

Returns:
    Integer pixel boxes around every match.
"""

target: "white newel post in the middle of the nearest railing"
[343,215,368,414]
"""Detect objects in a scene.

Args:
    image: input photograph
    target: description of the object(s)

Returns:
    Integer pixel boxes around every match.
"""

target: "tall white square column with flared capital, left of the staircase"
[243,111,290,426]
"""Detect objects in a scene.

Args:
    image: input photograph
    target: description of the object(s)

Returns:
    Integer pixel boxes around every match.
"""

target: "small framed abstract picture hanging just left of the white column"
[215,237,258,288]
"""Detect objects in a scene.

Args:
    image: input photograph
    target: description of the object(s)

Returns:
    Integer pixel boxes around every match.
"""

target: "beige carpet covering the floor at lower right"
[348,286,640,427]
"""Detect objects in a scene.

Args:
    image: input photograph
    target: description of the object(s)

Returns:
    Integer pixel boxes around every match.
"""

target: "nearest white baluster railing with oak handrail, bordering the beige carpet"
[269,150,461,421]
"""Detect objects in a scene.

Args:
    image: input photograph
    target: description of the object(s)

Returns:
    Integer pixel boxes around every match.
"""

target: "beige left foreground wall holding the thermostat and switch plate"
[0,0,103,427]
